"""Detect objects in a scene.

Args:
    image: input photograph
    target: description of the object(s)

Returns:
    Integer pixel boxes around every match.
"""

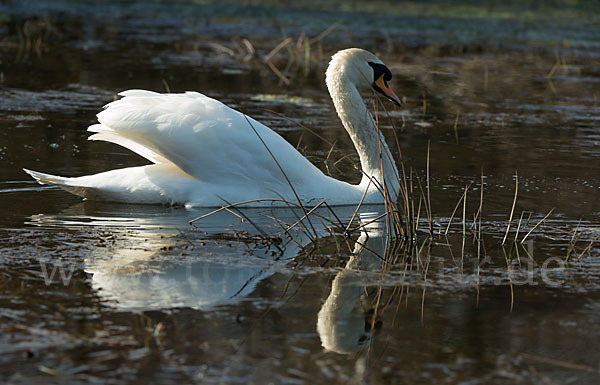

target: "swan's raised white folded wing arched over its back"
[89,90,319,183]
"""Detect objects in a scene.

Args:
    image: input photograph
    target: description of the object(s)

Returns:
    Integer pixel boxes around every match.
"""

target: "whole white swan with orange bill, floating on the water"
[24,48,400,207]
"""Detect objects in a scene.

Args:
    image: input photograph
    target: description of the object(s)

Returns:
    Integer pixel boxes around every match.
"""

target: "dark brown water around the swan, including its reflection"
[0,1,600,384]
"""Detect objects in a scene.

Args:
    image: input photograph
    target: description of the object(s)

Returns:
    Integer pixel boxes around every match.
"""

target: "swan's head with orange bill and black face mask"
[326,48,402,106]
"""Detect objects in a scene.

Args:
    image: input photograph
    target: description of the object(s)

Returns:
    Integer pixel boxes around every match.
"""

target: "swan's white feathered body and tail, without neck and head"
[32,90,361,207]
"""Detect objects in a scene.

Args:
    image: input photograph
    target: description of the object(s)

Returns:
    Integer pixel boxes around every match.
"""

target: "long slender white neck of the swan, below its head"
[326,66,399,199]
